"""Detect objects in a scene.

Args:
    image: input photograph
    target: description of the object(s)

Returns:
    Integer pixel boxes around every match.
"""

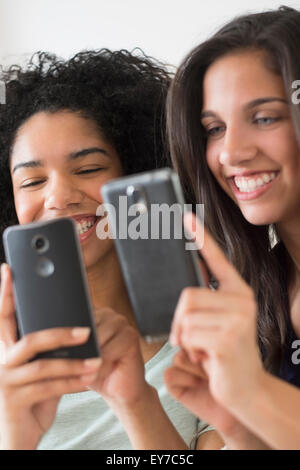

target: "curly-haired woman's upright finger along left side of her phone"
[0,263,17,346]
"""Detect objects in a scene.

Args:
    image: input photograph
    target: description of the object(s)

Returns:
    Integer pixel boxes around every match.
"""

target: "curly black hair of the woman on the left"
[0,49,171,262]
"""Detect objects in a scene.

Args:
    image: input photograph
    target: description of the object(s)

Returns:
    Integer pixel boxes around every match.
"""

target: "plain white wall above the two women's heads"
[0,0,300,65]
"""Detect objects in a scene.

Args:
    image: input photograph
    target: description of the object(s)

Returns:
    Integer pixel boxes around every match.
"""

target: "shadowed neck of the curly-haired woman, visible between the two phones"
[87,249,135,326]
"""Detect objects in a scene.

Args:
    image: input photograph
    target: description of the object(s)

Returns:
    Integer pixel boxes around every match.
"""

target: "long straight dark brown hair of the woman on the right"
[167,7,300,372]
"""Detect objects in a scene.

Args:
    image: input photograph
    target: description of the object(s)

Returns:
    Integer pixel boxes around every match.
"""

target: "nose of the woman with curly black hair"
[44,175,84,210]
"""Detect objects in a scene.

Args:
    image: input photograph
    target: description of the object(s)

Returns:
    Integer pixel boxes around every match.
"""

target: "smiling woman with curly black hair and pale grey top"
[0,49,220,449]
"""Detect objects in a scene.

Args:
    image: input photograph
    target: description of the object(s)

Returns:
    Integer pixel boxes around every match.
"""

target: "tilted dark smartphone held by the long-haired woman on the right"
[101,168,205,342]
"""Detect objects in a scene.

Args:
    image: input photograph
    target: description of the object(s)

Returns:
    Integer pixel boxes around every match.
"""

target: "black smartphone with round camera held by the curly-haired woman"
[3,218,100,359]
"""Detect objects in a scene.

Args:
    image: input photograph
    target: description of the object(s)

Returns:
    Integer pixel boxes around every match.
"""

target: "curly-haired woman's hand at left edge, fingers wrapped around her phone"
[0,264,99,450]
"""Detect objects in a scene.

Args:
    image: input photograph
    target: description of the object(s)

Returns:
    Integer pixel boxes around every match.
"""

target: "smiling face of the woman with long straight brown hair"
[201,51,300,225]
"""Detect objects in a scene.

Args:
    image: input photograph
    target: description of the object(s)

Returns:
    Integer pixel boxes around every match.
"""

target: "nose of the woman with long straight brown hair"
[219,125,258,166]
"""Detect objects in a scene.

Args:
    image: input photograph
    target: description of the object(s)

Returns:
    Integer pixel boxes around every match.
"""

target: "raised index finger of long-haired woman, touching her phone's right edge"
[184,212,246,291]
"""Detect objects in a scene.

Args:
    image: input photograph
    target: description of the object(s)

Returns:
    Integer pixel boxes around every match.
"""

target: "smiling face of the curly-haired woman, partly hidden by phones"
[10,111,123,267]
